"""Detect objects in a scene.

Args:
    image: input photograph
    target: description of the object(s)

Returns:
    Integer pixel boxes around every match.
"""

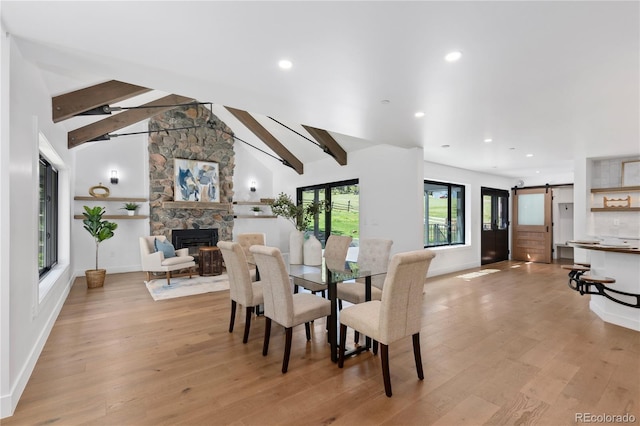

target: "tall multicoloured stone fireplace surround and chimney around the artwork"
[148,105,235,245]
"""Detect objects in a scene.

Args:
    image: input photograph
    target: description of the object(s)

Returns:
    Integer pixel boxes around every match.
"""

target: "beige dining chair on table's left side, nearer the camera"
[249,246,331,373]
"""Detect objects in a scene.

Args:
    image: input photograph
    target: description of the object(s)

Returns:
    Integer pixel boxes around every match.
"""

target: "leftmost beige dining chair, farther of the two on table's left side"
[218,241,264,343]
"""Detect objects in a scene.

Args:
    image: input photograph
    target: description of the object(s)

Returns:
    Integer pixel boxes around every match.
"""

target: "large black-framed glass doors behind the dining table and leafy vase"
[297,179,360,247]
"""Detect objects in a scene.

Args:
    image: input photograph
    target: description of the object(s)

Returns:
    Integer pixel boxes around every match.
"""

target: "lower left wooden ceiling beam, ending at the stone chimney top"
[67,95,194,148]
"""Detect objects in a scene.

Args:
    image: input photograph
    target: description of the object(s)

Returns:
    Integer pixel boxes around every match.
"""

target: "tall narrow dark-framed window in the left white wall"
[38,156,58,277]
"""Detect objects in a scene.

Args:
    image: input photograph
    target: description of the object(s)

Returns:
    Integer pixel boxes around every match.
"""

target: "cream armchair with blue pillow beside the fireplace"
[140,235,196,285]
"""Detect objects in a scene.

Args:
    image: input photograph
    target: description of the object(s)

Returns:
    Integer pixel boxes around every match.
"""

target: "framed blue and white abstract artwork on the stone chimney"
[173,158,220,203]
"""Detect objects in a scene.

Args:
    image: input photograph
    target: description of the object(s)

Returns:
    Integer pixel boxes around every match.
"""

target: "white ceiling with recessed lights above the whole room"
[0,0,640,183]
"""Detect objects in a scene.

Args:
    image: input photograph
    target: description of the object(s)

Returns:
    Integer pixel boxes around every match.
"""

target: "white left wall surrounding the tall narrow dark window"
[0,35,74,417]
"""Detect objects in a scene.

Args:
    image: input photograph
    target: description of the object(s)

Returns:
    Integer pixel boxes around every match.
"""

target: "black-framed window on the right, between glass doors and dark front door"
[424,180,464,247]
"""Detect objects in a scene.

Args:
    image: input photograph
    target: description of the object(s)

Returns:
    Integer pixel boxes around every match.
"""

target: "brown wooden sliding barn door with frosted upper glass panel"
[511,187,553,263]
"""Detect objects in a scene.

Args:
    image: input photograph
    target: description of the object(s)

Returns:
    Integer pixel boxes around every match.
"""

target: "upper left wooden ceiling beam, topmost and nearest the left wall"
[51,80,151,123]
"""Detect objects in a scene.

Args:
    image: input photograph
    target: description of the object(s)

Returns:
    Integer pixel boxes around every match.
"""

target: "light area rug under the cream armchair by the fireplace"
[144,274,229,300]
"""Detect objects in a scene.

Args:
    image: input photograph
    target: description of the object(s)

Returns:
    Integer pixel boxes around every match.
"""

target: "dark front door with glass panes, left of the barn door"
[480,187,509,265]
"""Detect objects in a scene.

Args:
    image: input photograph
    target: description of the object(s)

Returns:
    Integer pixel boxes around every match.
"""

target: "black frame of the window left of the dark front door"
[422,179,466,248]
